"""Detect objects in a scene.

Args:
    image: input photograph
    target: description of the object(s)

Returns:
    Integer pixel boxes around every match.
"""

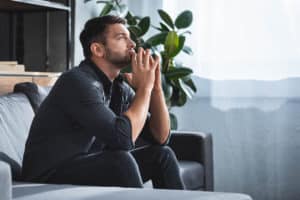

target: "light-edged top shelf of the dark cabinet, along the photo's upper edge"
[0,0,71,12]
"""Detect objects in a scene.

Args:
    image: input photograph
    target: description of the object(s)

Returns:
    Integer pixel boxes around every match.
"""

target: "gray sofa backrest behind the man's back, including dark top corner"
[0,82,51,180]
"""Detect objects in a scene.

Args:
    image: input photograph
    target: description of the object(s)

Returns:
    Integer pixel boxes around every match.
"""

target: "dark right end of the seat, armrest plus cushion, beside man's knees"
[169,131,214,191]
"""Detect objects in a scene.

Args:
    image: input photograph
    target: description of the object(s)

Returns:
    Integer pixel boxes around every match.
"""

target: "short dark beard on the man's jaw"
[105,47,131,69]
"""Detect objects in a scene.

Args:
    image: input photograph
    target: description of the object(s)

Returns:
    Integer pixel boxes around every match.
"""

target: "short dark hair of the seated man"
[80,15,125,58]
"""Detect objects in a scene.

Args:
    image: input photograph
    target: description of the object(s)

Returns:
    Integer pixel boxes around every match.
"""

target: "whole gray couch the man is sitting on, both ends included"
[0,83,251,200]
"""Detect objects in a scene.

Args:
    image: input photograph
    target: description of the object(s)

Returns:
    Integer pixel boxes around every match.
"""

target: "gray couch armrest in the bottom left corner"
[0,161,12,200]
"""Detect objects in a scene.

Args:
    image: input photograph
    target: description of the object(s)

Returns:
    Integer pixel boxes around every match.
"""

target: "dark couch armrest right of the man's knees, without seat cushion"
[169,131,213,191]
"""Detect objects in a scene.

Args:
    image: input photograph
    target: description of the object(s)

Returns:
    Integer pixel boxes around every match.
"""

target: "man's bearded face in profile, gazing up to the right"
[105,24,135,68]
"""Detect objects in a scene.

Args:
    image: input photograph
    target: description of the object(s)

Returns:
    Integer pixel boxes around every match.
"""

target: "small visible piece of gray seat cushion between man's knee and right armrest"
[179,160,204,190]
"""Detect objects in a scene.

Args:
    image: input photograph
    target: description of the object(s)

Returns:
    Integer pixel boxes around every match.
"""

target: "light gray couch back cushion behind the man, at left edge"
[0,93,34,180]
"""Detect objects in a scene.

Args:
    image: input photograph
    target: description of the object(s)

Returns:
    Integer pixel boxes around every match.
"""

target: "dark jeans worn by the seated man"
[47,146,184,189]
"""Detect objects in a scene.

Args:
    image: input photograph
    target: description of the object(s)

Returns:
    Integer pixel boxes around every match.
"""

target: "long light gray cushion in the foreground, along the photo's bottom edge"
[13,184,251,200]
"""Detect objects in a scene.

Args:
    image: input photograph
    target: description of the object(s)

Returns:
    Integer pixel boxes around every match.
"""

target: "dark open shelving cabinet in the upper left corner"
[0,0,73,72]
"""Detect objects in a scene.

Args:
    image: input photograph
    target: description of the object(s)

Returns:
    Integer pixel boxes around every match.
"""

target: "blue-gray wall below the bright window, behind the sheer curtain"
[173,77,300,200]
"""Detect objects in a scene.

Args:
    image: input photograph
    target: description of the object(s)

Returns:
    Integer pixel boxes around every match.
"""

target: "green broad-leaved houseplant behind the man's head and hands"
[85,0,197,129]
